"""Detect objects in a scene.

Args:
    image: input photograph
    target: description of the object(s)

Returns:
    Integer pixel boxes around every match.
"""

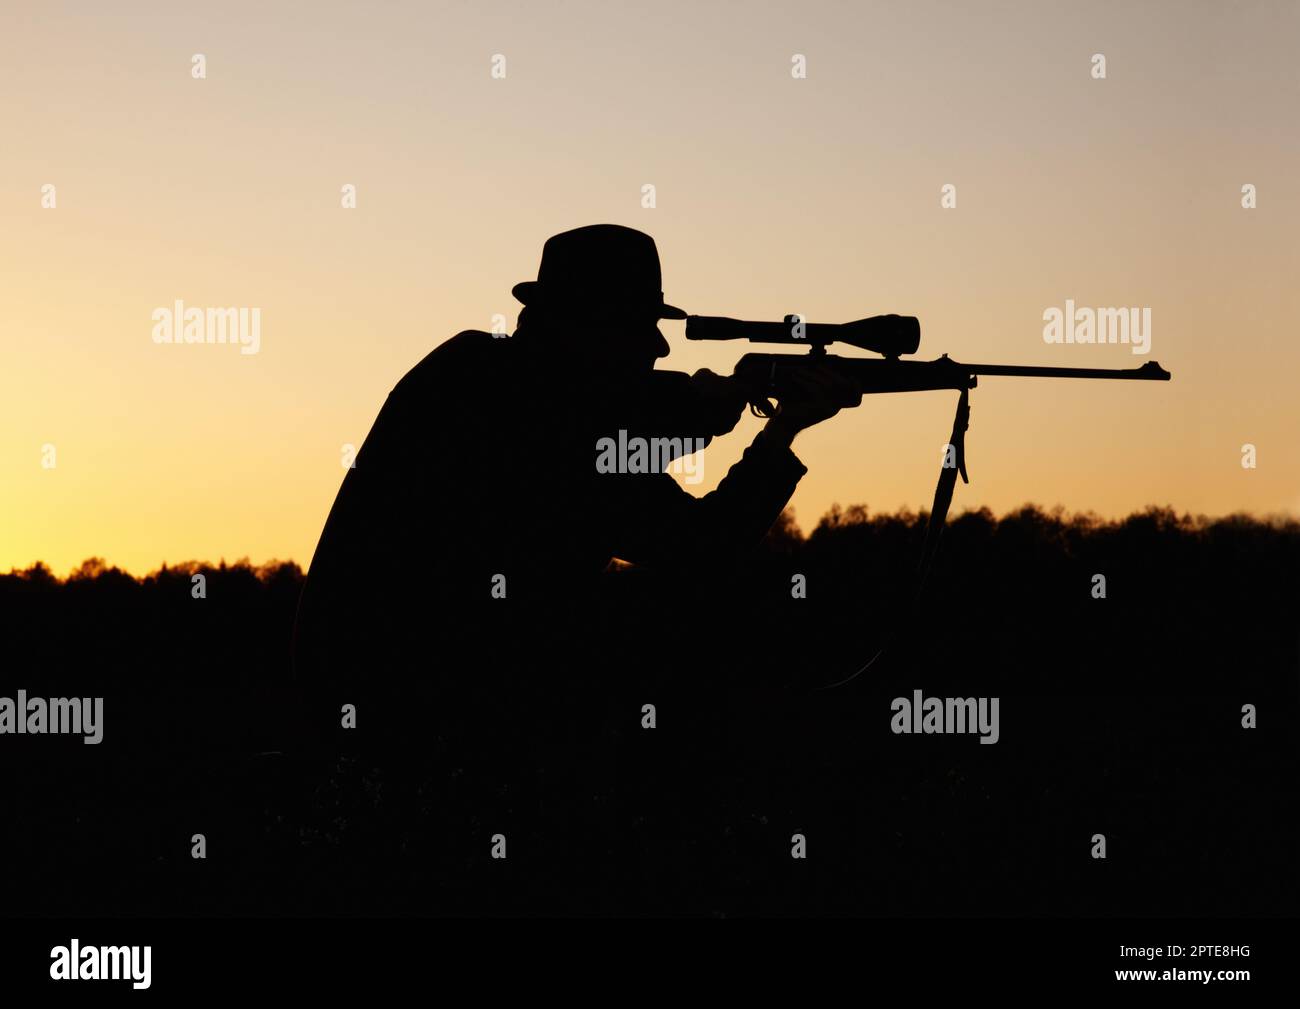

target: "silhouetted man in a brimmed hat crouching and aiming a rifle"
[295,225,861,733]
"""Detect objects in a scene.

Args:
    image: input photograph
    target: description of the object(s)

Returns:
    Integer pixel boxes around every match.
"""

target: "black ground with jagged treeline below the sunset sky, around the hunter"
[0,510,1300,915]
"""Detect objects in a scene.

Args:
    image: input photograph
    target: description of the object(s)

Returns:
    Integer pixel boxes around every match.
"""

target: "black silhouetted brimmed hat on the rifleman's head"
[511,224,686,319]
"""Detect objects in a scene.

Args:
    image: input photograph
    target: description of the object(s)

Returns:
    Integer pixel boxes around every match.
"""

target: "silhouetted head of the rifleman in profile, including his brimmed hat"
[514,224,686,371]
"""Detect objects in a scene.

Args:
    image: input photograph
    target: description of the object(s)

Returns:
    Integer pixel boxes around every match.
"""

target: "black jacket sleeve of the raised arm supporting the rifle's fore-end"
[599,433,807,566]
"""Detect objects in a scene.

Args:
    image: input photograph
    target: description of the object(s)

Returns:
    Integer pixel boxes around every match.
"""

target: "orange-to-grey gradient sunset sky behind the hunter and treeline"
[0,0,1300,573]
